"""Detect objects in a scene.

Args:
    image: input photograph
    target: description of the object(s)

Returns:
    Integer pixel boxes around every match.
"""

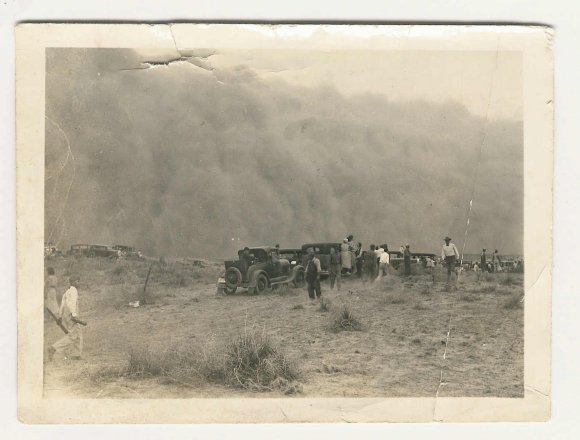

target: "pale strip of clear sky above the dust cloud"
[140,49,523,119]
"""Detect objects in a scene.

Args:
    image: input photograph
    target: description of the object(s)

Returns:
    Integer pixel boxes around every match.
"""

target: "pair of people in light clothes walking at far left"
[44,267,87,360]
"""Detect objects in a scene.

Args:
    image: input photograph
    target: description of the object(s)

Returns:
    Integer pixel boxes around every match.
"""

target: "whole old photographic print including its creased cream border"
[16,23,553,423]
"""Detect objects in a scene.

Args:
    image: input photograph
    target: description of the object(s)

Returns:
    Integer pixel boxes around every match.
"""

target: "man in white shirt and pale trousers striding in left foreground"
[48,275,87,360]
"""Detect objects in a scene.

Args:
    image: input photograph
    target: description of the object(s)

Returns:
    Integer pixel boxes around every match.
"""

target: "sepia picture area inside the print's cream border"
[45,49,524,398]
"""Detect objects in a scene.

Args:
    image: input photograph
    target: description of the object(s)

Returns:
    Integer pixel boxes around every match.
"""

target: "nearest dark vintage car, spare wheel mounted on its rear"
[218,246,304,295]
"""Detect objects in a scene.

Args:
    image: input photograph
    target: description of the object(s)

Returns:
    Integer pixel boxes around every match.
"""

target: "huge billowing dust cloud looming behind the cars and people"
[45,49,523,257]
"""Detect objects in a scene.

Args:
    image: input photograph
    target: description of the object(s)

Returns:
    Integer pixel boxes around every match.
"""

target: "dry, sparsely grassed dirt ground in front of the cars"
[44,258,524,398]
